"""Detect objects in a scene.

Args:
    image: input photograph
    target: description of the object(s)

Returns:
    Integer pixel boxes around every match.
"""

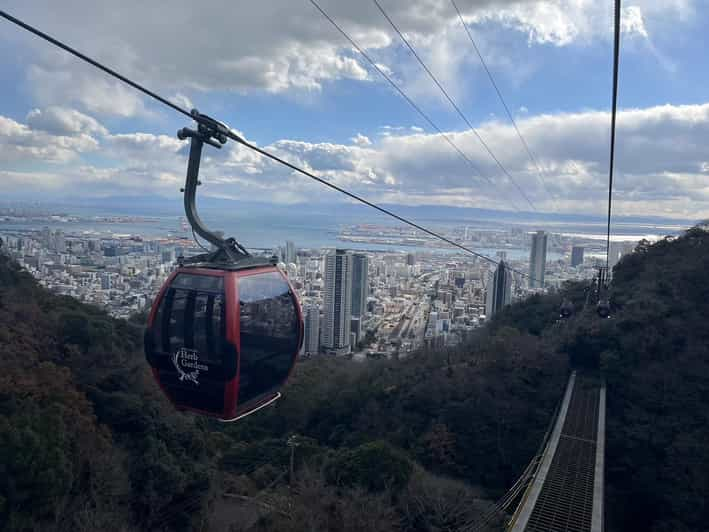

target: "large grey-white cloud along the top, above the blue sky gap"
[0,0,693,116]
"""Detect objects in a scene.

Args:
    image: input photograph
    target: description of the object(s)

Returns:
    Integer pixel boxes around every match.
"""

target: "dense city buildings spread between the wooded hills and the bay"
[0,209,629,359]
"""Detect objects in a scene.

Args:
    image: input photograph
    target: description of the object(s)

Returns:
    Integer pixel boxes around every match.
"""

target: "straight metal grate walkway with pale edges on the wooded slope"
[508,373,606,532]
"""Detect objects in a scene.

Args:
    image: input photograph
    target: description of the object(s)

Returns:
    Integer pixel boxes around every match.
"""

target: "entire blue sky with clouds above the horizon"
[0,0,709,219]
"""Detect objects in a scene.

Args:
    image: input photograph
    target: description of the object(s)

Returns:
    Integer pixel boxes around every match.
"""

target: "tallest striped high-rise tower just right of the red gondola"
[322,249,353,354]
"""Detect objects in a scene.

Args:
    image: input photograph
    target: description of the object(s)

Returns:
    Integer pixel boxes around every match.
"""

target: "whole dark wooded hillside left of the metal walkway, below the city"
[0,250,565,531]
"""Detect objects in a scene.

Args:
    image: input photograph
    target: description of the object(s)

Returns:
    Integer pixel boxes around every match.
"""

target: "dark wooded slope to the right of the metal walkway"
[596,228,709,532]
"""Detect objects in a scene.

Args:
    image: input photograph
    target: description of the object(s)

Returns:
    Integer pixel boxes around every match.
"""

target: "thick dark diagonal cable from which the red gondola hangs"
[0,7,548,286]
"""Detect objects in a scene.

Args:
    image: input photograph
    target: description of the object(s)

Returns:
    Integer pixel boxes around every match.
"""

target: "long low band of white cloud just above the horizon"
[6,103,709,218]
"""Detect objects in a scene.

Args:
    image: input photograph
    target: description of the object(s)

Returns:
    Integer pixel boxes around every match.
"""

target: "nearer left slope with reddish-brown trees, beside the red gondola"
[0,256,215,530]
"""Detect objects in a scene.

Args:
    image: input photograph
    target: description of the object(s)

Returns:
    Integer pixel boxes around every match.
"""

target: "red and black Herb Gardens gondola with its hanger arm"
[145,115,303,421]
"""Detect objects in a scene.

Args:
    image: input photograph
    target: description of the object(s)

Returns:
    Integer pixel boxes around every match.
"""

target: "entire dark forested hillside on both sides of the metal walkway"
[0,225,709,531]
